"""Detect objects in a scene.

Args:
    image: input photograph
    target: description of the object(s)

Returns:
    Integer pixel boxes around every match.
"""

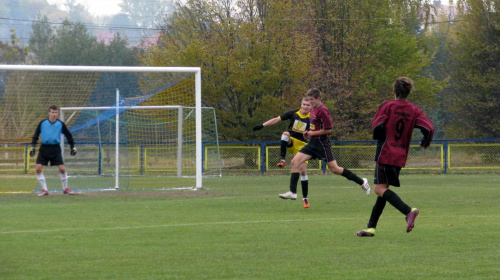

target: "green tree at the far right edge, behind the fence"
[445,0,500,138]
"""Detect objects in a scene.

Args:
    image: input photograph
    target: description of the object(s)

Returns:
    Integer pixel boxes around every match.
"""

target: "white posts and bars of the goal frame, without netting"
[0,65,203,190]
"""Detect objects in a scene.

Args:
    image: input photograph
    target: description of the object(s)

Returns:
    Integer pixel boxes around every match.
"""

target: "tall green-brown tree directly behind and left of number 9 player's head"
[302,0,444,139]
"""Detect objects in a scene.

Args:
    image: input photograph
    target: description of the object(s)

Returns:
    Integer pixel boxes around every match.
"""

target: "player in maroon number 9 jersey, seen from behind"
[356,77,434,237]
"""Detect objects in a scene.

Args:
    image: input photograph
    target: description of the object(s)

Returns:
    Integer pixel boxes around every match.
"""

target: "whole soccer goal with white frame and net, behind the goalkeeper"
[0,65,221,191]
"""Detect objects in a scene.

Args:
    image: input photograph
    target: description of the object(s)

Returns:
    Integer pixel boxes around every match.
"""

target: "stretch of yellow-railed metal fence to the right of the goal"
[205,139,500,174]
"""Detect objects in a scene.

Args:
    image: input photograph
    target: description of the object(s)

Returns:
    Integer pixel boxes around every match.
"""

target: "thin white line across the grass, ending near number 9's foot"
[0,218,352,234]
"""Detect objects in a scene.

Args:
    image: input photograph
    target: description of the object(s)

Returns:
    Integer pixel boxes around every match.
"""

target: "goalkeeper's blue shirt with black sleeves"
[31,119,75,148]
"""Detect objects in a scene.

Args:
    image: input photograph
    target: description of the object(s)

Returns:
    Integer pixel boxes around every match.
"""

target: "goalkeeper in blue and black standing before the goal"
[30,105,76,196]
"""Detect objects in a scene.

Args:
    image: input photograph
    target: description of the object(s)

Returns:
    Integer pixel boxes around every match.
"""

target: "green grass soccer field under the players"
[0,174,500,280]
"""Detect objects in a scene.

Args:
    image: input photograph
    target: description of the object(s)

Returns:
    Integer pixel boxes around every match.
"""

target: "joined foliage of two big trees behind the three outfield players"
[142,0,444,140]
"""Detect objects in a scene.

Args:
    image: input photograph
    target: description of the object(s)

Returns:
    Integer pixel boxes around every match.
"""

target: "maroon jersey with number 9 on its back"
[372,100,434,167]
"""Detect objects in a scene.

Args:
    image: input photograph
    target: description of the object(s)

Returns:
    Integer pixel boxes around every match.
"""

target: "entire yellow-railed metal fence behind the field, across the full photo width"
[0,139,500,175]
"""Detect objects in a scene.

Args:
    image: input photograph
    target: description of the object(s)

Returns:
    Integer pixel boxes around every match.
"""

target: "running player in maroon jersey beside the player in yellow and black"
[279,88,371,208]
